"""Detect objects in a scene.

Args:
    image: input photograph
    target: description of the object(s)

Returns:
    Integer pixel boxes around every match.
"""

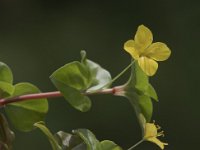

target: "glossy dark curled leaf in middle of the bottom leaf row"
[73,129,101,150]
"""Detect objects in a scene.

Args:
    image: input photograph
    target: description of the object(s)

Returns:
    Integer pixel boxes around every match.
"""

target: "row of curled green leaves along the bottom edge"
[35,122,122,150]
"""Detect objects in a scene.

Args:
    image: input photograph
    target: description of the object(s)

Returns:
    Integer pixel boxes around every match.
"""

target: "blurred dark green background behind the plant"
[0,0,200,150]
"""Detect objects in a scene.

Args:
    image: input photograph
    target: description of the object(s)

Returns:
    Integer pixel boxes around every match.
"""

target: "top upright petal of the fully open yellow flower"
[134,25,153,52]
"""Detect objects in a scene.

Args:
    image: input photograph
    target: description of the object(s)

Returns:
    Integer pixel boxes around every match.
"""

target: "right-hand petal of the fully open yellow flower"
[143,42,171,61]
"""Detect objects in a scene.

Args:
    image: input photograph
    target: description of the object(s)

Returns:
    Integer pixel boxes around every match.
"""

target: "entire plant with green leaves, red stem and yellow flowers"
[0,25,171,150]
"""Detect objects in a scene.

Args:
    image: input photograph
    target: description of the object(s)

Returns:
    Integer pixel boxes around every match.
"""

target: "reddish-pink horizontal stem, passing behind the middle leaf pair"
[0,87,120,106]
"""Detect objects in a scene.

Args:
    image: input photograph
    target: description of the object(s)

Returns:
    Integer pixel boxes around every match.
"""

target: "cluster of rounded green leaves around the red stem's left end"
[0,62,48,131]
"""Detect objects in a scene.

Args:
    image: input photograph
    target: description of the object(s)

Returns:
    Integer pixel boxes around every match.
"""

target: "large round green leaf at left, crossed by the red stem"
[5,83,48,131]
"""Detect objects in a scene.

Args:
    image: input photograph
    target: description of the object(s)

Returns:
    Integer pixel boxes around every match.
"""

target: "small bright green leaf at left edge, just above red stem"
[0,81,15,98]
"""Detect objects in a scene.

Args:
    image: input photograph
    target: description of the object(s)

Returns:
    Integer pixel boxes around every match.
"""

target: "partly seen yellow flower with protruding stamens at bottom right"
[143,123,168,149]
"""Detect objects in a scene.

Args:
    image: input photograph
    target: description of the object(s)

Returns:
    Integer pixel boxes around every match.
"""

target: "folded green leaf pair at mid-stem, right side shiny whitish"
[50,51,111,112]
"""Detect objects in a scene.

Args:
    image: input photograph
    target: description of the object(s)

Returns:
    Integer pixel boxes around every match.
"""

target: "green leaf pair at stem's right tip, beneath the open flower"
[124,63,154,129]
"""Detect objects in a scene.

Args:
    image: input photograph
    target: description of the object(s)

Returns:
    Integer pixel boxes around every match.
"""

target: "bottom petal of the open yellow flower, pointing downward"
[138,57,158,76]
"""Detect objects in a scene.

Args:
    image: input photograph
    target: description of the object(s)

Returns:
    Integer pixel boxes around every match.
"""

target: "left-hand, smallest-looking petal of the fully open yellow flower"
[124,40,139,60]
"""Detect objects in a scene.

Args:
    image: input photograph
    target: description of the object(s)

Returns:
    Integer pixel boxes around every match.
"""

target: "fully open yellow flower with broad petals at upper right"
[124,25,171,76]
